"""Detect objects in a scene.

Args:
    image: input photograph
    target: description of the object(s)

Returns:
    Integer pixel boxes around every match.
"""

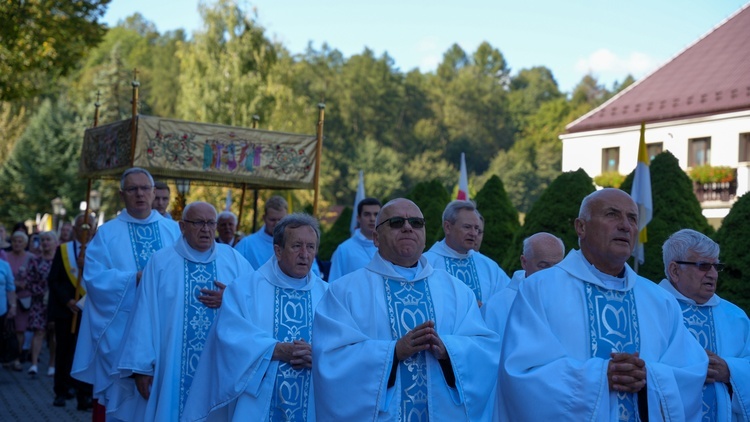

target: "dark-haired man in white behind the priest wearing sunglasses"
[328,198,381,282]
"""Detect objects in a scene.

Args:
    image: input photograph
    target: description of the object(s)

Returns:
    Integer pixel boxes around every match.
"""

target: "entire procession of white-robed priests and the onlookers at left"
[0,168,750,422]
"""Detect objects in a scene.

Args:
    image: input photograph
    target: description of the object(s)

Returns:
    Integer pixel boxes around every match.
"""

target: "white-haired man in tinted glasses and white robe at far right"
[659,229,750,421]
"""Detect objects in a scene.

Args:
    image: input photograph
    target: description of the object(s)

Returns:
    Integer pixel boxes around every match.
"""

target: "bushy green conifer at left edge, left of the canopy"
[0,100,86,221]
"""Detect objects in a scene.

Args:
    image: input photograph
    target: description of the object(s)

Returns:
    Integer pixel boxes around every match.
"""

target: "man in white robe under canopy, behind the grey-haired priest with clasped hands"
[235,195,320,276]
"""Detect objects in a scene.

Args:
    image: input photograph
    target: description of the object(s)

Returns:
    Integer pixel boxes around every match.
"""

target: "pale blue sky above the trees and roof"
[104,0,746,92]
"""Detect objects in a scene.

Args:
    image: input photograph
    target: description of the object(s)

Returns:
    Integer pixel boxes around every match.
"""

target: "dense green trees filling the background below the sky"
[0,0,631,227]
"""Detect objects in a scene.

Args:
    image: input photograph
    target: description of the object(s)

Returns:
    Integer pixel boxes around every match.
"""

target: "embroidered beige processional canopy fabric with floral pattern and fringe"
[80,115,316,189]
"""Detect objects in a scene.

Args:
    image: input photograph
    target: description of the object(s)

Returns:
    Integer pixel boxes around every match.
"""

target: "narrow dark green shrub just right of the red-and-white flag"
[475,176,520,262]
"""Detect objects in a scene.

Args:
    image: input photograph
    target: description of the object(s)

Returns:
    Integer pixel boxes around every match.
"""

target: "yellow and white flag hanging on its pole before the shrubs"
[630,123,654,264]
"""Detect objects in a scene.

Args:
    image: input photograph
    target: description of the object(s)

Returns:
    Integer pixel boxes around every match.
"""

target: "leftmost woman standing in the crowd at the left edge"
[8,230,34,371]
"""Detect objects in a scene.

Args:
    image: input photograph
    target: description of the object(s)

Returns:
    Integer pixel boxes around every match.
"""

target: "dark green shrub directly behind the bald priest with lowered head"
[502,169,594,274]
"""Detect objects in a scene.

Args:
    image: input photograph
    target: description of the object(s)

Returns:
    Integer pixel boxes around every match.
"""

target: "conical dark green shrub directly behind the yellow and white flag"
[620,151,713,282]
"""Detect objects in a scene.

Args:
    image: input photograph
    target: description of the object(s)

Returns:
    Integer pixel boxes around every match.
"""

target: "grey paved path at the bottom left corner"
[0,344,91,422]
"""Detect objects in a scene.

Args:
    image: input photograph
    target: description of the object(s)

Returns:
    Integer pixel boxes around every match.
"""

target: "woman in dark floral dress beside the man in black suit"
[26,231,57,375]
